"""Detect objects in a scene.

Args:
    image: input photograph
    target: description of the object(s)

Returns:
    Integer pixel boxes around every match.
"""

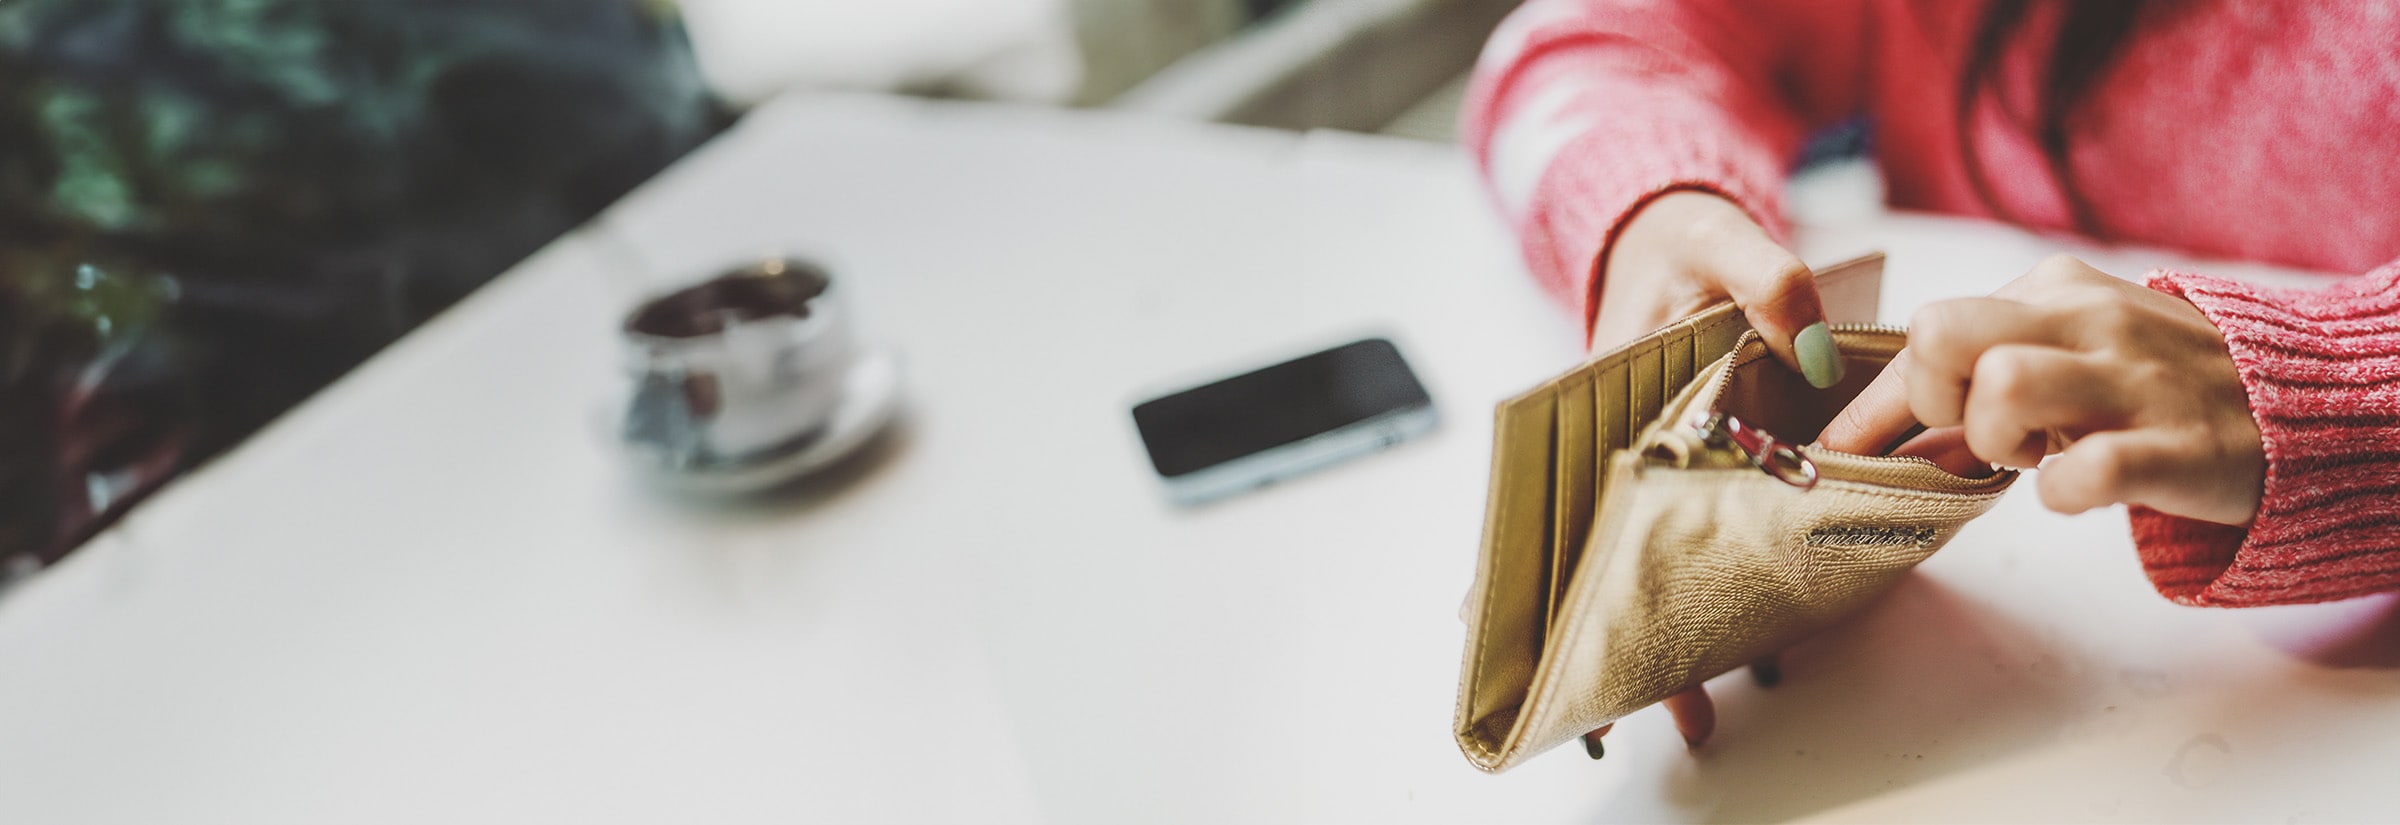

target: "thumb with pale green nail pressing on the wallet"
[1718,228,1843,389]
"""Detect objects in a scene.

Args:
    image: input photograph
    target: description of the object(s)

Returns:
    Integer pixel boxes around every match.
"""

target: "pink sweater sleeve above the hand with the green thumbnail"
[1462,0,1870,329]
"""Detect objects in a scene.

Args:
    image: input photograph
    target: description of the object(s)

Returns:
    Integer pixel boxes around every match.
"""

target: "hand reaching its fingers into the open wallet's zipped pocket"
[1822,254,2266,525]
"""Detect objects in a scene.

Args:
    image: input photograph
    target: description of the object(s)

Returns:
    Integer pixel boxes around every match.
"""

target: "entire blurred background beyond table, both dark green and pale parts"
[0,0,1514,573]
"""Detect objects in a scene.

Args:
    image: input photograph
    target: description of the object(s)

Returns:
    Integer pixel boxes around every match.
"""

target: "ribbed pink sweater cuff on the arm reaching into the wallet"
[2134,261,2400,607]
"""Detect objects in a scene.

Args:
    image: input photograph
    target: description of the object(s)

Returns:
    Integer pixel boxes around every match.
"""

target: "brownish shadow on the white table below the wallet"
[1594,576,2102,823]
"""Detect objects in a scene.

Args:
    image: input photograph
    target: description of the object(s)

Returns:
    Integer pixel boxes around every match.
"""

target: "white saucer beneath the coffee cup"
[638,350,900,496]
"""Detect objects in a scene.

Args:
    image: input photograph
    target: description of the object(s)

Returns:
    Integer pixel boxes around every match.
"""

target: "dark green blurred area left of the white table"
[0,0,718,559]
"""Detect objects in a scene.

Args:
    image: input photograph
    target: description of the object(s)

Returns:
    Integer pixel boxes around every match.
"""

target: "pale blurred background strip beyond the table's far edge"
[682,0,1517,139]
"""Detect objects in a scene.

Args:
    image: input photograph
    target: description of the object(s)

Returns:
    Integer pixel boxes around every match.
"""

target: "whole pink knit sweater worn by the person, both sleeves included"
[1464,0,2400,604]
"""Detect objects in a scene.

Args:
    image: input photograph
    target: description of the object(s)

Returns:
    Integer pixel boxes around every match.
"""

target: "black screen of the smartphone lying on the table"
[1133,338,1433,477]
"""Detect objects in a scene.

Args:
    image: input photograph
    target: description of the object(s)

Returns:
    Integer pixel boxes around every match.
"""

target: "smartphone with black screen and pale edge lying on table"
[1133,338,1438,506]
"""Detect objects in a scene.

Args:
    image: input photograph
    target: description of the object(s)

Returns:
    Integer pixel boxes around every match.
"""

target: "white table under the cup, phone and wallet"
[0,98,2400,823]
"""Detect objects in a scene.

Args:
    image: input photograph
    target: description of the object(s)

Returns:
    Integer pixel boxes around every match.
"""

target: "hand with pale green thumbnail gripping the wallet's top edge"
[1591,192,1841,386]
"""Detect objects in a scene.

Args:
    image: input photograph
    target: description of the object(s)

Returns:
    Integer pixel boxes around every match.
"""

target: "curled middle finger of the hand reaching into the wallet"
[1966,343,2119,468]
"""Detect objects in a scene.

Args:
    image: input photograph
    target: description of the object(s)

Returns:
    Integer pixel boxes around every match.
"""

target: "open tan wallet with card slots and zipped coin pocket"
[1454,254,2016,772]
